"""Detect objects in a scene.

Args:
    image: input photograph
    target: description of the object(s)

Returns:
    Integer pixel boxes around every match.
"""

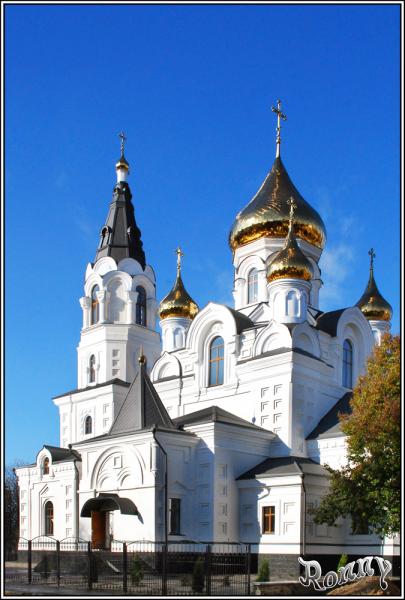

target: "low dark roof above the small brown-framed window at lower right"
[237,456,327,480]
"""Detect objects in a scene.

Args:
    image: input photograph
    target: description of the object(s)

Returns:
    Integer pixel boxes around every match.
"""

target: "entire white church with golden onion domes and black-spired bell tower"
[16,119,396,571]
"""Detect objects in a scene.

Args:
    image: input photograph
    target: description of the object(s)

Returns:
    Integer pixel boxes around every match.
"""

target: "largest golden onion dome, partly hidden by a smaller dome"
[229,156,326,251]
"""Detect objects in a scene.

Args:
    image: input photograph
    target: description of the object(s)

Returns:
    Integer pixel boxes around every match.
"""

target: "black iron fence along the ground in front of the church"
[6,536,251,596]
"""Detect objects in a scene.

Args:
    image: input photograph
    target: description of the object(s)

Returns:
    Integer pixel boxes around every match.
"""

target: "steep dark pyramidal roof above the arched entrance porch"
[108,362,176,436]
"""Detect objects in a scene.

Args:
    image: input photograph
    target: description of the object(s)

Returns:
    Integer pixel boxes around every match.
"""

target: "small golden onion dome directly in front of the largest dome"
[267,227,314,283]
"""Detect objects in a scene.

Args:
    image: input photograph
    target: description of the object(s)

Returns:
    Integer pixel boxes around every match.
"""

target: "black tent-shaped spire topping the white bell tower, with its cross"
[95,132,146,269]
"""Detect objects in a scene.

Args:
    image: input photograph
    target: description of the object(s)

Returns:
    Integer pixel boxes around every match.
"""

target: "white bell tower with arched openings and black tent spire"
[78,133,160,388]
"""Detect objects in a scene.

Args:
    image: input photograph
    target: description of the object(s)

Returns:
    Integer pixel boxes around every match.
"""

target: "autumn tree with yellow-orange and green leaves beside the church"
[314,334,401,537]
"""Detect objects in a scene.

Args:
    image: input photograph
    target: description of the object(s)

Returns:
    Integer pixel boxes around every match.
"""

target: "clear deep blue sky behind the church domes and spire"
[5,5,400,463]
